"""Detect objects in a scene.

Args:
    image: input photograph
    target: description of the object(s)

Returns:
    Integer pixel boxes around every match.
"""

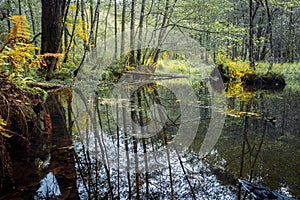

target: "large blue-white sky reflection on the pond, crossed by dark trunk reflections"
[75,135,237,200]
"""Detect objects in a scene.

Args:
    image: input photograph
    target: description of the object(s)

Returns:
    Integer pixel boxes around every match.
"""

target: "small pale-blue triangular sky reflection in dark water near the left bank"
[34,172,61,200]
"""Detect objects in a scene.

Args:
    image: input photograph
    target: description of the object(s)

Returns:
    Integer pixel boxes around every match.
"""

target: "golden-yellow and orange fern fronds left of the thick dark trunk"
[0,15,62,76]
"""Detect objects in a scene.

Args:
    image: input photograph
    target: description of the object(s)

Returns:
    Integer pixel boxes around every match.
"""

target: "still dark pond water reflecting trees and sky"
[0,76,300,199]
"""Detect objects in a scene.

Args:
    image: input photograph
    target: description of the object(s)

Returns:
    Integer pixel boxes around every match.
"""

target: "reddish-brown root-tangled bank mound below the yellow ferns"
[0,73,51,190]
